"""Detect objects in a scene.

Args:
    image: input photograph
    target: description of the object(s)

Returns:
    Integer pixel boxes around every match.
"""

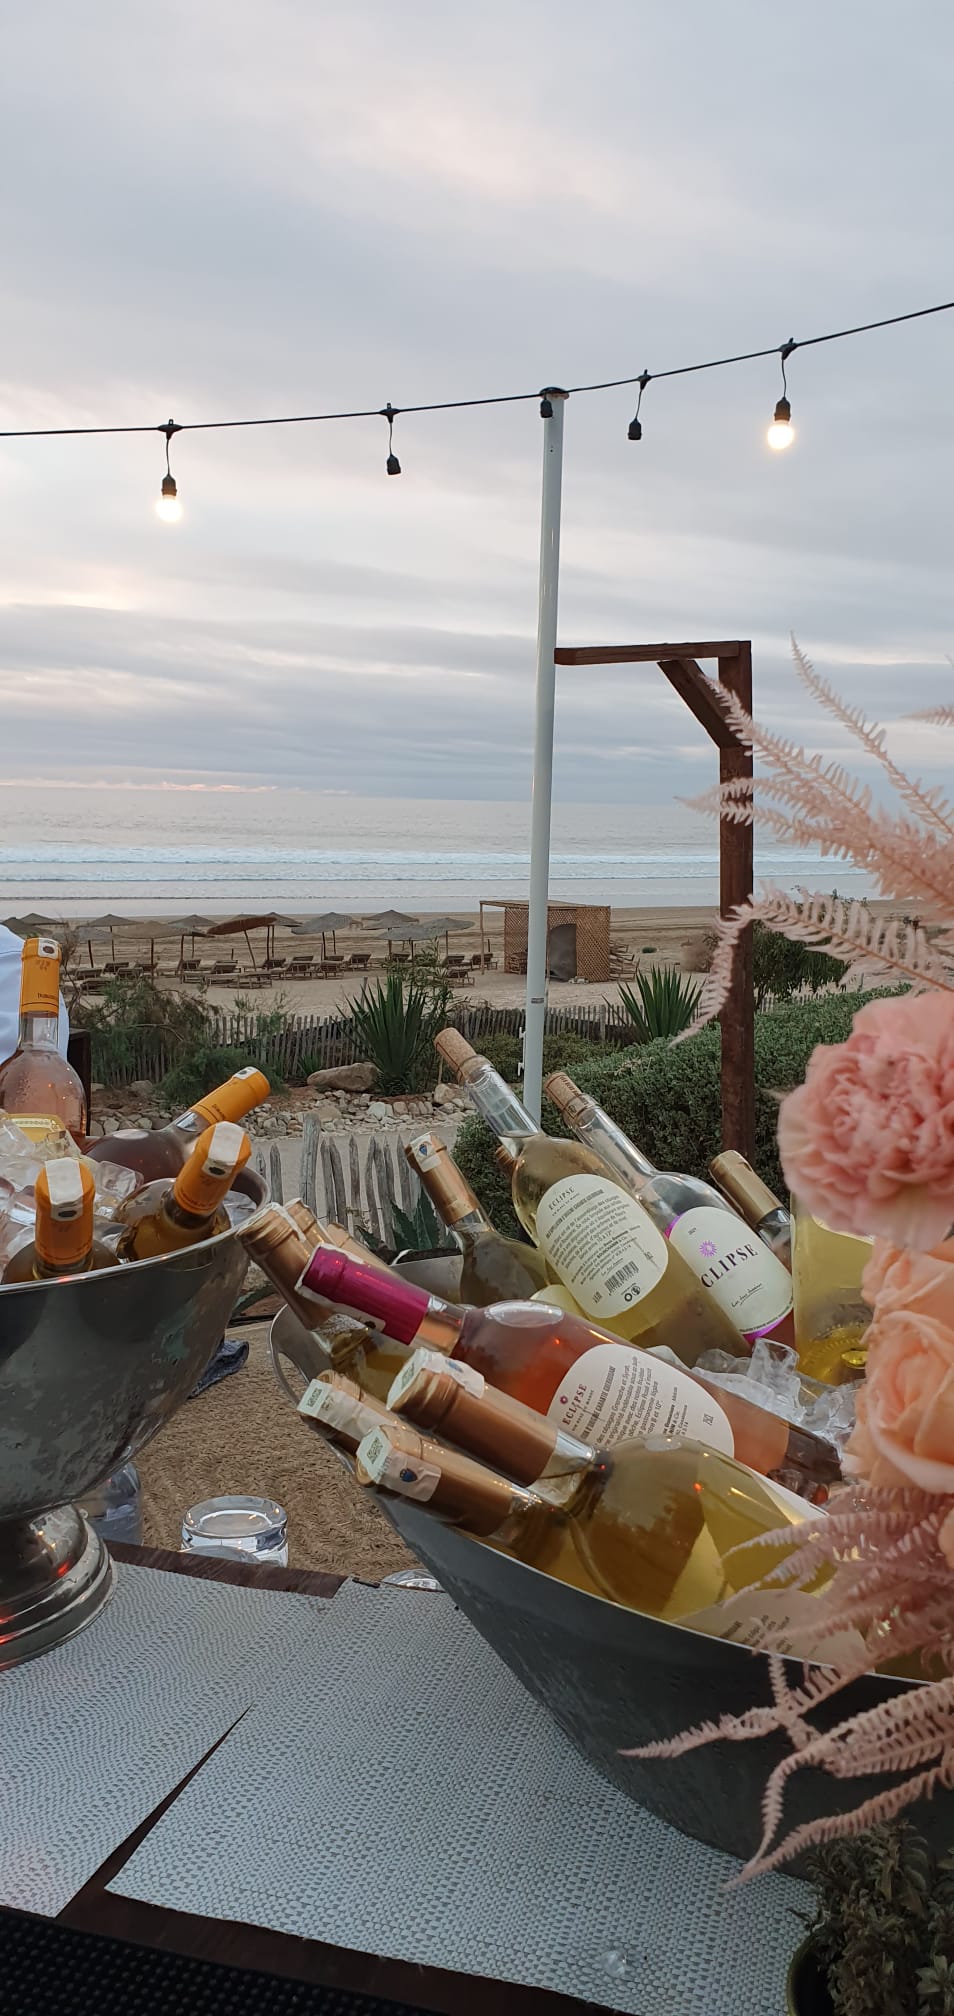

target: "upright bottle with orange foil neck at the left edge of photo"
[0,937,87,1147]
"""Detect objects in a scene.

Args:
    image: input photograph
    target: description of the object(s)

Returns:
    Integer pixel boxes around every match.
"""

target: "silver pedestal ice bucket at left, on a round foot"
[0,1171,266,1669]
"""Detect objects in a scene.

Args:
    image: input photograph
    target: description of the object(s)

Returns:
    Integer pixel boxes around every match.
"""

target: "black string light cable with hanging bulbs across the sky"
[0,300,954,522]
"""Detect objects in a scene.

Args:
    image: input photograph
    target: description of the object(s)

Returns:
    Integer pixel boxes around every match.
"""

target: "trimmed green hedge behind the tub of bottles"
[454,994,883,1234]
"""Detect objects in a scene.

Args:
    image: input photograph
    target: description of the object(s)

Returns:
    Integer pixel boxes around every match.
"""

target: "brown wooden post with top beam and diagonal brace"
[555,637,754,1161]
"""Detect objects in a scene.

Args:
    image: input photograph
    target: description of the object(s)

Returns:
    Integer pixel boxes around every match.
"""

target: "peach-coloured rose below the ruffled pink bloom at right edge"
[845,1308,954,1496]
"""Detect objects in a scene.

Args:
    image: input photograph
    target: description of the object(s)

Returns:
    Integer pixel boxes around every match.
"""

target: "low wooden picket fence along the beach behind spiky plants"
[93,1002,633,1085]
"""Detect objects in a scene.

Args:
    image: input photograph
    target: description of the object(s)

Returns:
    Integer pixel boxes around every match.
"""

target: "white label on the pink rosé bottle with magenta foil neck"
[547,1341,730,1459]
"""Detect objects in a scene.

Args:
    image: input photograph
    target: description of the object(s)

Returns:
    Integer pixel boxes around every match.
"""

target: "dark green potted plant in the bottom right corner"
[787,1820,954,2016]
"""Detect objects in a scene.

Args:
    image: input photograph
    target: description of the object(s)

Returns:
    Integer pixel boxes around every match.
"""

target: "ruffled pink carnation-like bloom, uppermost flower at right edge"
[779,992,954,1250]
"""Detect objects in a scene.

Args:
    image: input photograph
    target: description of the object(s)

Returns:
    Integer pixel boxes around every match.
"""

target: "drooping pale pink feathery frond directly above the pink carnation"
[676,889,954,1042]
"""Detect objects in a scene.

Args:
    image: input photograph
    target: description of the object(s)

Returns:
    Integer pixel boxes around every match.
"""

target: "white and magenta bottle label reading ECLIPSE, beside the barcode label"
[670,1204,793,1337]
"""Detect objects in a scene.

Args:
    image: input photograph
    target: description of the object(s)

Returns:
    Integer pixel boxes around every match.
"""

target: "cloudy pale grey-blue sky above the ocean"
[0,0,954,816]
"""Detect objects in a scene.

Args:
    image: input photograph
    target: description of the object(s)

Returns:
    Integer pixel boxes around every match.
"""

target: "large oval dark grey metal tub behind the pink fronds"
[270,1310,954,1871]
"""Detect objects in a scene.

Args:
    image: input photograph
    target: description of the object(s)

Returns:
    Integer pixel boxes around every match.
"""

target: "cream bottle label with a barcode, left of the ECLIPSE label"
[536,1175,666,1318]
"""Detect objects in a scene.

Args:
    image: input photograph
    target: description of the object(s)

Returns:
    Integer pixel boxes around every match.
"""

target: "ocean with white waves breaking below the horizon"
[0,784,865,917]
